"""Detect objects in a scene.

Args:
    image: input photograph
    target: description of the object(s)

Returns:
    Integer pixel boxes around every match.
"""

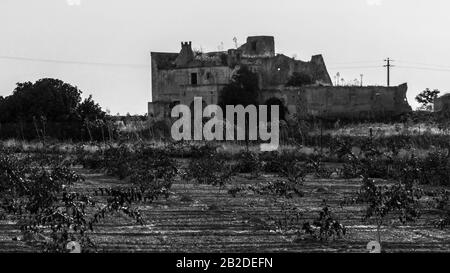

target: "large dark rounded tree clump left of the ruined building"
[0,78,108,140]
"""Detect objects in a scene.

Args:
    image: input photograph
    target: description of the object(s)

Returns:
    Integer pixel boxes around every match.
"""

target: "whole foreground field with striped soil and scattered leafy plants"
[0,140,450,252]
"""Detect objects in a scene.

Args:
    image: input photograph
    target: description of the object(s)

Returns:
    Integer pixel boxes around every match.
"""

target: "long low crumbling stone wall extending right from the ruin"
[262,84,412,119]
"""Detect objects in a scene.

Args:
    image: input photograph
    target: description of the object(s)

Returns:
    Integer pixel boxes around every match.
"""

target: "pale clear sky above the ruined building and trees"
[0,0,450,114]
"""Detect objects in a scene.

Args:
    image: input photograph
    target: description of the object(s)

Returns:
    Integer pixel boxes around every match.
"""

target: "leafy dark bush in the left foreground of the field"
[0,153,141,252]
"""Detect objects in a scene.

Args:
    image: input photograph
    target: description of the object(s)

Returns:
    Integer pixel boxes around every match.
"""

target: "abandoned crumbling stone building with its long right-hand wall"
[148,36,411,119]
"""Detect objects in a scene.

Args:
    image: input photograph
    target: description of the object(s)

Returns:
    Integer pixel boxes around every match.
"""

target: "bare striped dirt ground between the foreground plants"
[0,165,450,253]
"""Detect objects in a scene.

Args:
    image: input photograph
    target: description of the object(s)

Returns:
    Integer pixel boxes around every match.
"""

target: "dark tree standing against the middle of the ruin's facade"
[219,66,259,110]
